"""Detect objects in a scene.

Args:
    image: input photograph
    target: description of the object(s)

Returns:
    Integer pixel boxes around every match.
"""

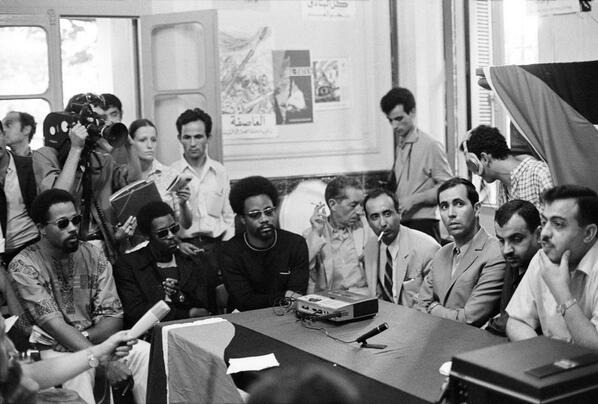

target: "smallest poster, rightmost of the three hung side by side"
[312,58,350,109]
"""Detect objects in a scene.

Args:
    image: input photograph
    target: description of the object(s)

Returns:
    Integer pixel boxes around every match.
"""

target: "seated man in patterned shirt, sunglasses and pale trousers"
[9,189,149,403]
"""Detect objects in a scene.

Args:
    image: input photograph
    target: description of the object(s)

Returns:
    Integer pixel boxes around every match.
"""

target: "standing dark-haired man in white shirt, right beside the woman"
[172,108,235,252]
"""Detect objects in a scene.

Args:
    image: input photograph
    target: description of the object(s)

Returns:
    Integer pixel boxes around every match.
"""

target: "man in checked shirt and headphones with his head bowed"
[461,125,552,210]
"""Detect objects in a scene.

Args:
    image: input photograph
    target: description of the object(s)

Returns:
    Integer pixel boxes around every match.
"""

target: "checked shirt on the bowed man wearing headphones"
[498,156,553,211]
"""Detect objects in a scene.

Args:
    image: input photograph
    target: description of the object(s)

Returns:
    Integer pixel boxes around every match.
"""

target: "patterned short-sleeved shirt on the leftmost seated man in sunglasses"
[8,242,123,336]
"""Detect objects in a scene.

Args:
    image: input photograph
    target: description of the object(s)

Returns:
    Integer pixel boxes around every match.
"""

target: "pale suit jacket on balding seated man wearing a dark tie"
[364,226,440,307]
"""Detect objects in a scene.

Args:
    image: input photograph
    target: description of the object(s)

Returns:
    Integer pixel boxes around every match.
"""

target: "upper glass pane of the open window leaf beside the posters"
[152,23,206,90]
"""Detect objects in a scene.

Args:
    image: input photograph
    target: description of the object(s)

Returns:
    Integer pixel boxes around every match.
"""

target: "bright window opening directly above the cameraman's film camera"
[60,18,137,123]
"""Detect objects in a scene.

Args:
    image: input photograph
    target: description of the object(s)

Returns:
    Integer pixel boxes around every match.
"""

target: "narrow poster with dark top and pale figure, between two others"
[272,50,314,125]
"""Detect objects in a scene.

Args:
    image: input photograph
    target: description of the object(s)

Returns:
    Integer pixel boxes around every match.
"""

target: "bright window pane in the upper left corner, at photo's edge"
[0,27,49,95]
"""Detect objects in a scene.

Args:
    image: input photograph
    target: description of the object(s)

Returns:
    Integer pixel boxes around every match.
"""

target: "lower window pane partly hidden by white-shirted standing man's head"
[150,94,207,164]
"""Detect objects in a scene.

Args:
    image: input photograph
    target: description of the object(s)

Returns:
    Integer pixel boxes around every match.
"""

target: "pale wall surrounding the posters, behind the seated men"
[151,0,393,179]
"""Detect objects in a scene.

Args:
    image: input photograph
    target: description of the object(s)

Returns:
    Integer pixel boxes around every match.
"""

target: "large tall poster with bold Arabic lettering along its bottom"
[219,21,277,138]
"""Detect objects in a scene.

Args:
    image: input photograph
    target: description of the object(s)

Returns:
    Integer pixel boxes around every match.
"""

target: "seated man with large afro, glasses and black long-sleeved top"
[220,176,309,311]
